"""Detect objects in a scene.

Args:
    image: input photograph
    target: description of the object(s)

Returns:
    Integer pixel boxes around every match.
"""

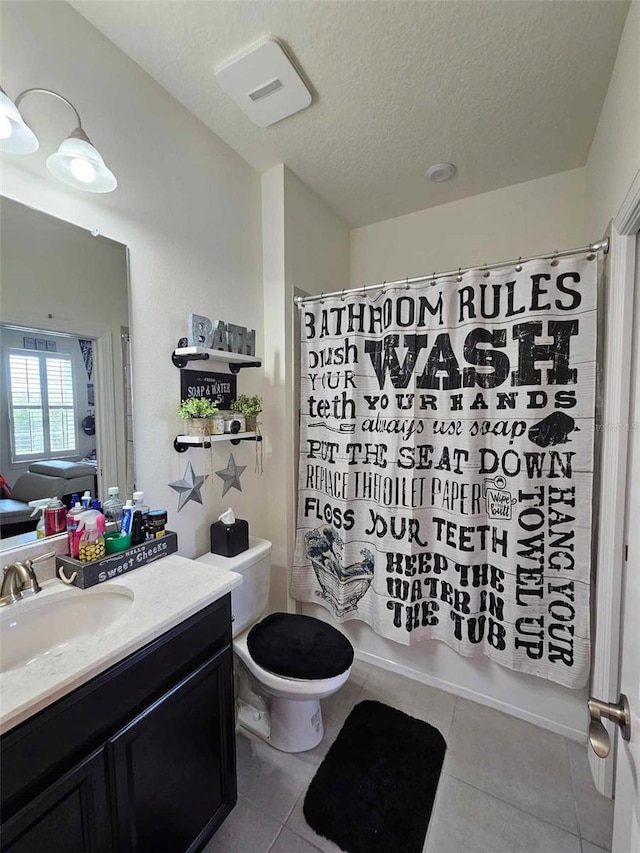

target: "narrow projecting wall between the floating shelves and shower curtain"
[262,166,349,609]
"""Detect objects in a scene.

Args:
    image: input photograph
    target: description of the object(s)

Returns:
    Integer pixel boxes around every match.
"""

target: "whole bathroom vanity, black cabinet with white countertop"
[0,556,241,853]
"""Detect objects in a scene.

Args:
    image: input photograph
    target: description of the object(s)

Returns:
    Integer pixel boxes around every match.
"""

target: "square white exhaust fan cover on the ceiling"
[215,37,311,127]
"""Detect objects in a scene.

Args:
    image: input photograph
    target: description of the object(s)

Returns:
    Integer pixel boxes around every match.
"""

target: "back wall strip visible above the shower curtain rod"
[351,169,588,287]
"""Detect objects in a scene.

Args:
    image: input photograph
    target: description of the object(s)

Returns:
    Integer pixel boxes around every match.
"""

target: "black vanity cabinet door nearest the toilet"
[107,647,236,853]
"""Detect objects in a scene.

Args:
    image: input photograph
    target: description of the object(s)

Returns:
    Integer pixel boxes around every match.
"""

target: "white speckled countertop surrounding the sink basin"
[0,554,242,733]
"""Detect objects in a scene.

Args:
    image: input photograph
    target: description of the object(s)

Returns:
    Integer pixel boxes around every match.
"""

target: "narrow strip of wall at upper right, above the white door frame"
[586,0,640,234]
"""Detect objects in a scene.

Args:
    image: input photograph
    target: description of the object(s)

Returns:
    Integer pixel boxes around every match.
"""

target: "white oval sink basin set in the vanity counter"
[0,585,133,672]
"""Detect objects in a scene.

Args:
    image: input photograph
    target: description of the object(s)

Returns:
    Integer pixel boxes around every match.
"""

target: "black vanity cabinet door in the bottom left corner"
[2,747,111,853]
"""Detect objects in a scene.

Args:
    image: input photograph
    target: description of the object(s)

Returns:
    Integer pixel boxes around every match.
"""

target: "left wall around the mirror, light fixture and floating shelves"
[2,2,269,556]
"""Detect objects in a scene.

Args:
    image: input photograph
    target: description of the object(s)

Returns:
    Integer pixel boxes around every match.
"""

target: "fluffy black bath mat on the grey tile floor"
[303,701,447,853]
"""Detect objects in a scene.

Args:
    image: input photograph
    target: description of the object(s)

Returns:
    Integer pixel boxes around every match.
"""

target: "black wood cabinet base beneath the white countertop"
[0,595,237,853]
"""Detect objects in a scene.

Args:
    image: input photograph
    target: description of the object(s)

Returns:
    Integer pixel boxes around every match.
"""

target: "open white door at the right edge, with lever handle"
[612,230,640,853]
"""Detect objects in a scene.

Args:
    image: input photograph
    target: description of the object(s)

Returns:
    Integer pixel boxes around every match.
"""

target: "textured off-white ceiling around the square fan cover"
[71,0,628,226]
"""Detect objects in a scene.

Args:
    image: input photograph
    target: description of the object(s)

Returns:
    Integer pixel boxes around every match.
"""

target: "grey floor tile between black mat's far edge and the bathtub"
[358,666,456,740]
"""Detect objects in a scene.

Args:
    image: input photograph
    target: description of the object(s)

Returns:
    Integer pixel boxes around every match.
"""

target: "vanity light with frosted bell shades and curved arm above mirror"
[0,89,118,193]
